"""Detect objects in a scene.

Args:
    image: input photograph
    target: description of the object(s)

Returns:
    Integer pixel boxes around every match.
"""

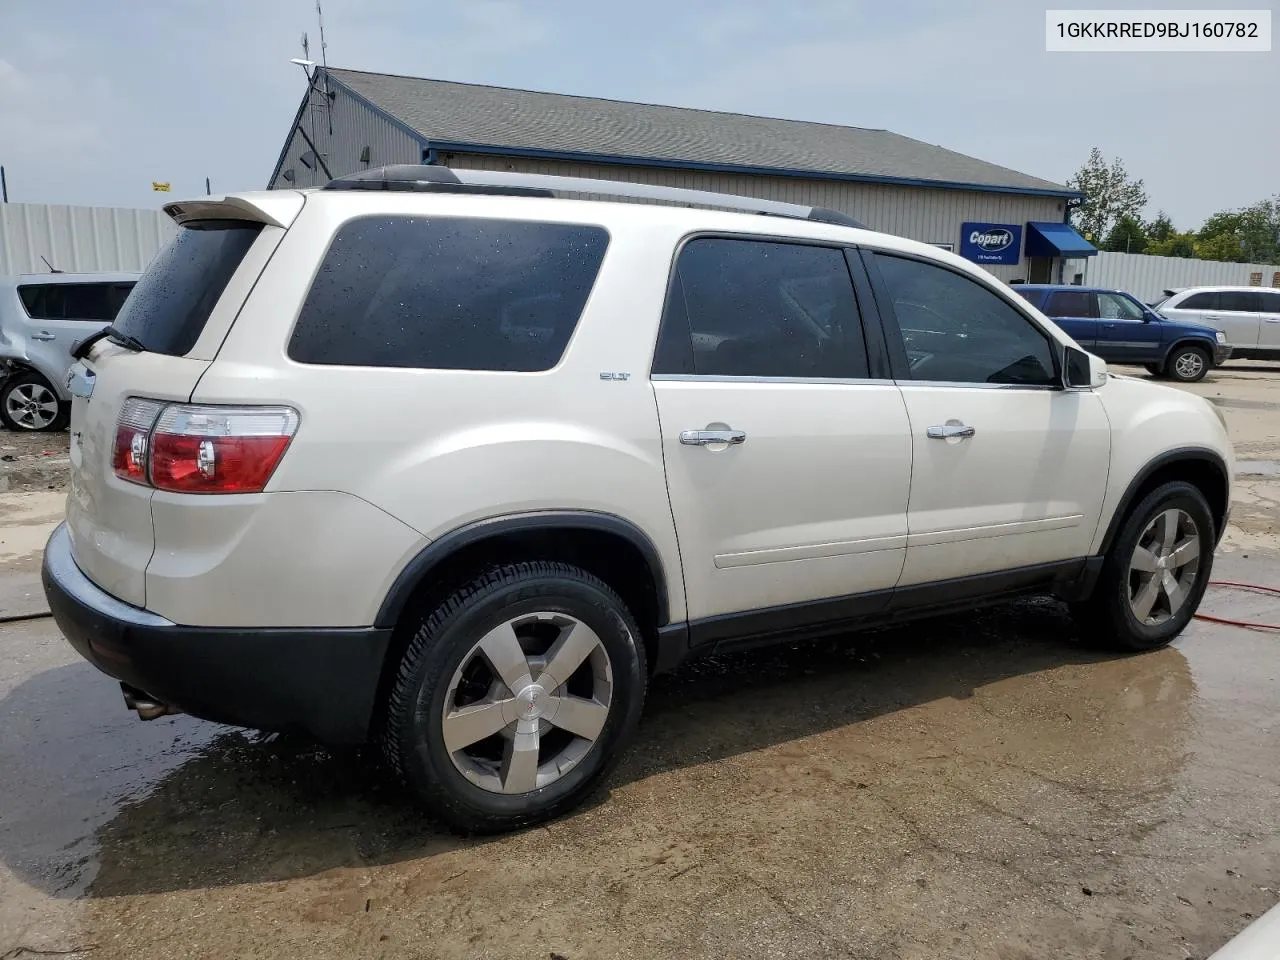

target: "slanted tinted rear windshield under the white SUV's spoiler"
[111,220,262,357]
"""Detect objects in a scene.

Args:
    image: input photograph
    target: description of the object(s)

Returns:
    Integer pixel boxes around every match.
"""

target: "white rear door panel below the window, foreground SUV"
[653,379,911,620]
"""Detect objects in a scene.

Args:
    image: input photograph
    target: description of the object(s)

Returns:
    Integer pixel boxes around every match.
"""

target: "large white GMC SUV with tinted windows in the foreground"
[44,168,1231,831]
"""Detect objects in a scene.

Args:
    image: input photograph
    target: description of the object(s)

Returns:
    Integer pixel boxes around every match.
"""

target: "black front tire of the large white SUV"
[1071,480,1217,650]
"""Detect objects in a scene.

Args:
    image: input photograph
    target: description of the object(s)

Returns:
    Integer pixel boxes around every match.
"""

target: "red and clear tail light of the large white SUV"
[114,397,298,493]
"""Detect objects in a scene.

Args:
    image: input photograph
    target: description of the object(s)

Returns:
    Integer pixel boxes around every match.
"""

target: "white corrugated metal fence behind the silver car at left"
[0,204,175,275]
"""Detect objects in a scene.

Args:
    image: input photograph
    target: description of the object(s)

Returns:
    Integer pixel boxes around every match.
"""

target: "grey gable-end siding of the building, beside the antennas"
[268,82,422,189]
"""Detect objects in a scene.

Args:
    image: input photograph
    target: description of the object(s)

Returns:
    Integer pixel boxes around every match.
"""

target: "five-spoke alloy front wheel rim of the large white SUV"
[1129,507,1201,626]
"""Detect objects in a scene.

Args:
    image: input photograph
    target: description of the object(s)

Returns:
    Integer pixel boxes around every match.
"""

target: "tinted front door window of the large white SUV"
[876,253,1056,385]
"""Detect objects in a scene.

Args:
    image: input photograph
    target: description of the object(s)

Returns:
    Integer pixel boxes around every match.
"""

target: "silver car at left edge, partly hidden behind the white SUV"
[0,273,138,430]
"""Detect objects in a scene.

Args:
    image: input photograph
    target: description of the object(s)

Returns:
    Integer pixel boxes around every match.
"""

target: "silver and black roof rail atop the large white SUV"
[324,164,864,227]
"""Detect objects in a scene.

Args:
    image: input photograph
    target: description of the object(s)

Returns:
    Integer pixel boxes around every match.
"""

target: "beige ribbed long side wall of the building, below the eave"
[445,154,1062,280]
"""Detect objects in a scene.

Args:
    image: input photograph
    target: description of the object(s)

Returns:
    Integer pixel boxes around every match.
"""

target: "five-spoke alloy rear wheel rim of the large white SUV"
[442,612,613,794]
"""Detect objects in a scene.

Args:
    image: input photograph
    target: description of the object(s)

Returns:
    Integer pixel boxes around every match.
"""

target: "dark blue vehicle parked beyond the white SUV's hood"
[1014,283,1231,383]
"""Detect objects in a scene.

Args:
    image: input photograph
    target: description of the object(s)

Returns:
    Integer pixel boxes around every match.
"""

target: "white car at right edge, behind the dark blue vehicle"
[1152,287,1280,360]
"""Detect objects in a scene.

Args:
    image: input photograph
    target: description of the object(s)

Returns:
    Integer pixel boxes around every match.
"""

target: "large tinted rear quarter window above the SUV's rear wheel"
[289,216,609,372]
